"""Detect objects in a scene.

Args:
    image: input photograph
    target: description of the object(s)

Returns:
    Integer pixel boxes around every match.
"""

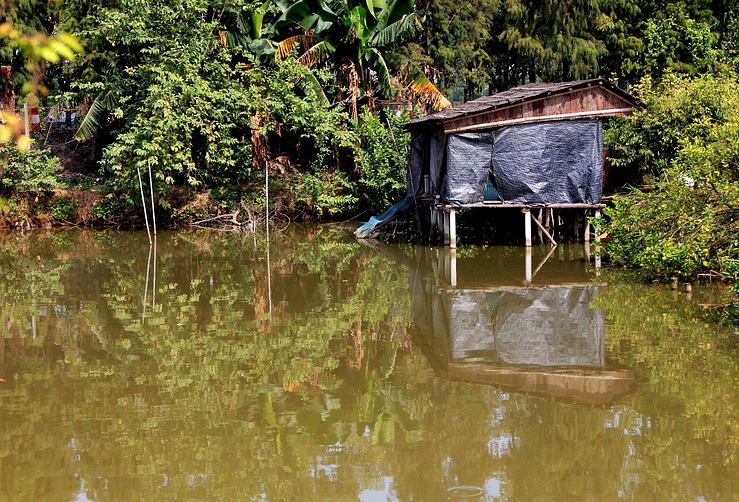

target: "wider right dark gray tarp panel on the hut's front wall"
[493,120,603,204]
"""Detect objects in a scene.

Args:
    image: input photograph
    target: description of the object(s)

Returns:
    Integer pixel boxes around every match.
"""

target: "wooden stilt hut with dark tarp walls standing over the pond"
[357,79,639,247]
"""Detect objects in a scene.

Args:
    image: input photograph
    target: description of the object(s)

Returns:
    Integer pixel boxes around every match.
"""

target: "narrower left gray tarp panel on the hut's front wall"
[441,131,493,204]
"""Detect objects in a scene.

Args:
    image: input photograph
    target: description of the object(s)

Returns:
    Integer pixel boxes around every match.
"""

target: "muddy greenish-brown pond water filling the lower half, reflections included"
[0,226,739,501]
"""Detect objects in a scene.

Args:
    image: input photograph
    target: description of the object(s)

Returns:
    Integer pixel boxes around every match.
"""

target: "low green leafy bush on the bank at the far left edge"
[0,144,60,191]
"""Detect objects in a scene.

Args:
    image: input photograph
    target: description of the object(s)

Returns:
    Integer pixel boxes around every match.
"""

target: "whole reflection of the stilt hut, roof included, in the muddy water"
[370,241,634,404]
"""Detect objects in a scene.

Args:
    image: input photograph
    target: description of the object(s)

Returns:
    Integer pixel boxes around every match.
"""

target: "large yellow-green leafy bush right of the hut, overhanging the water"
[600,71,739,280]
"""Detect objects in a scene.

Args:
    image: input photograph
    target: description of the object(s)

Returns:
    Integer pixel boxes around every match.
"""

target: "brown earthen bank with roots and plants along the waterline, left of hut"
[0,170,346,230]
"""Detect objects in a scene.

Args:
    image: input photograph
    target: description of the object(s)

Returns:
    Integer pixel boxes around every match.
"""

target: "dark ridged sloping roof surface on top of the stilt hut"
[406,78,639,128]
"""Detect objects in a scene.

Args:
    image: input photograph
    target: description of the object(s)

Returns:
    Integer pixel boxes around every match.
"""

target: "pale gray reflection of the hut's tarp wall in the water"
[444,286,605,368]
